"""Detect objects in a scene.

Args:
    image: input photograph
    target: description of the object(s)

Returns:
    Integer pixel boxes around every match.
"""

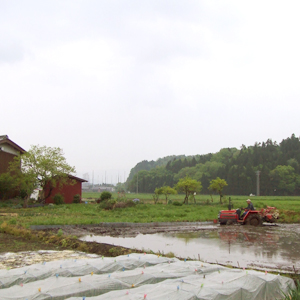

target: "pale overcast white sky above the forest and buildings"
[0,0,300,183]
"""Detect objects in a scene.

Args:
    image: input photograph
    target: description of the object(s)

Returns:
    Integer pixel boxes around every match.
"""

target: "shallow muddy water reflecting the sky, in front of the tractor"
[82,225,300,272]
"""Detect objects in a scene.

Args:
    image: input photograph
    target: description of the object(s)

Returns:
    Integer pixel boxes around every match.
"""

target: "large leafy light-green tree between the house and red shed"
[10,145,75,202]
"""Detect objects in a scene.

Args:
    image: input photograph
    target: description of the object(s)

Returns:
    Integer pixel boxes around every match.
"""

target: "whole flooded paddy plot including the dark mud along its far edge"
[4,222,300,274]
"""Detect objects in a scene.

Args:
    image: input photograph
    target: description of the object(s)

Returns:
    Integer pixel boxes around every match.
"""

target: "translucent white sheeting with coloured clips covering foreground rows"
[0,254,295,300]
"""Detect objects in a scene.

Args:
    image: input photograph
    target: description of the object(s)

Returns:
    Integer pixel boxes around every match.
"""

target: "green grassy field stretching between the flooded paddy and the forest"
[0,193,300,227]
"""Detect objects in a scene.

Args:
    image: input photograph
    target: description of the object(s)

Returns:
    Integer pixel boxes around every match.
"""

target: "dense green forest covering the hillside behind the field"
[126,134,300,195]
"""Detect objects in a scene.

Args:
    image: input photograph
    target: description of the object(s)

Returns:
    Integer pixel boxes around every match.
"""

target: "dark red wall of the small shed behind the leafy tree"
[45,179,82,204]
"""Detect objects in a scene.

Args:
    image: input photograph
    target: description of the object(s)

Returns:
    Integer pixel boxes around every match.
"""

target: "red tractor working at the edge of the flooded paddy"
[218,206,279,226]
